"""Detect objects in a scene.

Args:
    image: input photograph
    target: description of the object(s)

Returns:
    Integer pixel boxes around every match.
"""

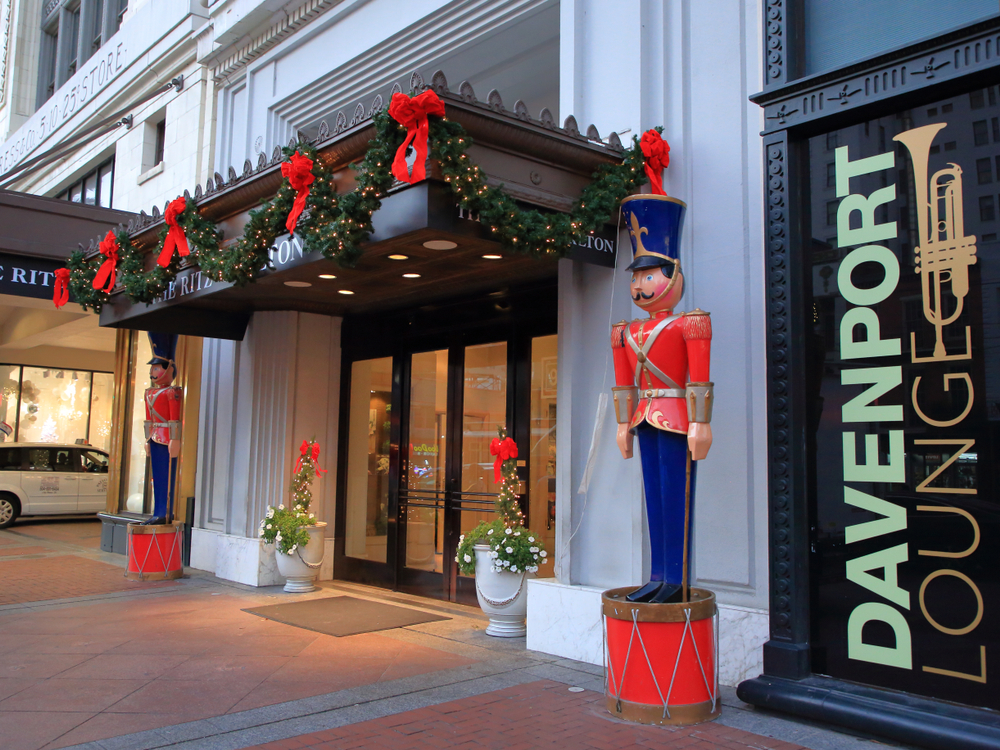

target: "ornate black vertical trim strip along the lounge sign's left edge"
[765,135,793,639]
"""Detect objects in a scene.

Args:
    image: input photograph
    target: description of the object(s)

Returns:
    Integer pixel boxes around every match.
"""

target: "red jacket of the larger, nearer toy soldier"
[611,310,712,435]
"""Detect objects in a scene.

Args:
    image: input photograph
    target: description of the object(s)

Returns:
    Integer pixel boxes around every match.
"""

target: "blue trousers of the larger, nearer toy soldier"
[636,422,697,584]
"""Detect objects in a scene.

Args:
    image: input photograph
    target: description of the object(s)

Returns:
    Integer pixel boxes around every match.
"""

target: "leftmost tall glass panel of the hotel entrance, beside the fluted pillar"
[345,357,392,562]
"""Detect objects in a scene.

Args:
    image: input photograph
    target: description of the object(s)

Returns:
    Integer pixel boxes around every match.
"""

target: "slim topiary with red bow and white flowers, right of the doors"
[455,427,548,575]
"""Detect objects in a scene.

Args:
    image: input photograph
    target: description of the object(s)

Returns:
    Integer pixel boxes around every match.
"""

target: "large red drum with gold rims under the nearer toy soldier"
[601,586,722,726]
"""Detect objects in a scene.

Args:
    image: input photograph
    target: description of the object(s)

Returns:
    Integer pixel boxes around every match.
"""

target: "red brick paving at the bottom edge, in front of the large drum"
[250,680,804,750]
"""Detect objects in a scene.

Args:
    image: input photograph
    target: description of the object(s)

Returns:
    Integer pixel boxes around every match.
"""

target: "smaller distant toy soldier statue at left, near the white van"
[143,333,182,525]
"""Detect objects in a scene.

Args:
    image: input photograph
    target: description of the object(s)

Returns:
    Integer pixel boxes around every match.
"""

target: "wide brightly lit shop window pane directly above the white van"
[17,367,91,443]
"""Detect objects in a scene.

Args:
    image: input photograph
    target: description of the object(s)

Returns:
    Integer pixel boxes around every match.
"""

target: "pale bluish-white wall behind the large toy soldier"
[528,0,768,684]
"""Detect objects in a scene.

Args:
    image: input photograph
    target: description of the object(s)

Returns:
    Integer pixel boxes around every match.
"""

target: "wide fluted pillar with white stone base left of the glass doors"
[191,312,341,586]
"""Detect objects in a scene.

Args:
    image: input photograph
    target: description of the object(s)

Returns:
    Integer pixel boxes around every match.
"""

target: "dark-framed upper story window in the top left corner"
[36,0,128,107]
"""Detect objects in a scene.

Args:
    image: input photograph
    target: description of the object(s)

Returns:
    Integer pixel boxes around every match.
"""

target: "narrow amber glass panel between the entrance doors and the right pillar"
[528,336,558,555]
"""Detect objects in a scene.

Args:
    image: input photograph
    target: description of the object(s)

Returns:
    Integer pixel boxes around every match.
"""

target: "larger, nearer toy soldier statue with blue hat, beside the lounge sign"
[611,195,713,602]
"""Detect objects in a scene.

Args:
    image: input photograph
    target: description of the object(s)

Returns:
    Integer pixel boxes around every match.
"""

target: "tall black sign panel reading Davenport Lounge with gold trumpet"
[806,87,1000,709]
